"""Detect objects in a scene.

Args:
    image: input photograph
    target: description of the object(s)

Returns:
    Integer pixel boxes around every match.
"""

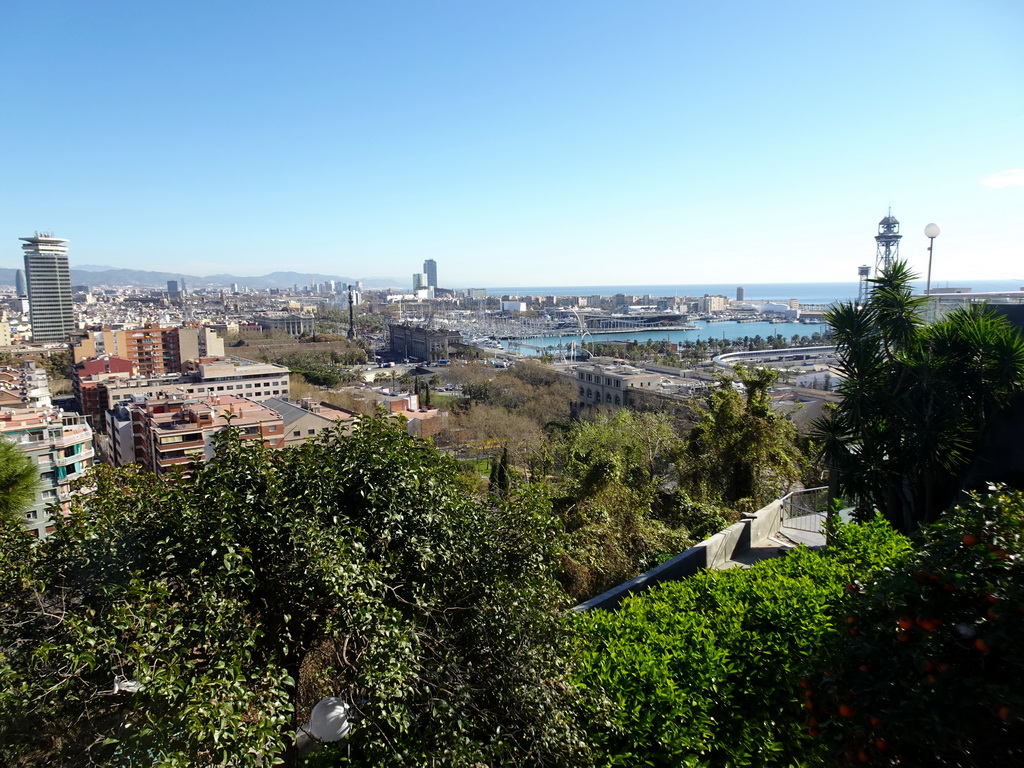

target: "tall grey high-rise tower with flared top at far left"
[18,232,75,341]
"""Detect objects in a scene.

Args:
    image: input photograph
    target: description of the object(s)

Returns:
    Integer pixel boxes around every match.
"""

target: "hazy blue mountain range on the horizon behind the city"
[0,264,403,291]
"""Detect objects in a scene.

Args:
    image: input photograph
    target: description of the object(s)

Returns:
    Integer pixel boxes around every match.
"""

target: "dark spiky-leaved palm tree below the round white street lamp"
[817,262,1024,531]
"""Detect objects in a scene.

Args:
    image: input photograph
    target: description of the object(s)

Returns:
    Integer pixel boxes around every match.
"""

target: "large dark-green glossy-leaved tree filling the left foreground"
[0,419,583,766]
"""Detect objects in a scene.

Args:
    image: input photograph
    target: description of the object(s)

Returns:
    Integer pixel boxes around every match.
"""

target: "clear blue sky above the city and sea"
[0,0,1024,287]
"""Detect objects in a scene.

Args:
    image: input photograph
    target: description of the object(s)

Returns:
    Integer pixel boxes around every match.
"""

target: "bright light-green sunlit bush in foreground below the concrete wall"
[578,520,908,768]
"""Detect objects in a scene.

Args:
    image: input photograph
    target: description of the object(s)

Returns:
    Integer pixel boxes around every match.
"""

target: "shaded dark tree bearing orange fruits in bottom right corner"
[803,488,1024,768]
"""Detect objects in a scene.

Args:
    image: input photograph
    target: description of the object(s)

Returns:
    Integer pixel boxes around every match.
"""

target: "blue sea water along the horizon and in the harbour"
[488,280,1022,355]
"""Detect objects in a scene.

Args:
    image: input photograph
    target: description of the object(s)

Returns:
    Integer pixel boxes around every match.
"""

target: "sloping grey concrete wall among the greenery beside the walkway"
[572,500,782,611]
